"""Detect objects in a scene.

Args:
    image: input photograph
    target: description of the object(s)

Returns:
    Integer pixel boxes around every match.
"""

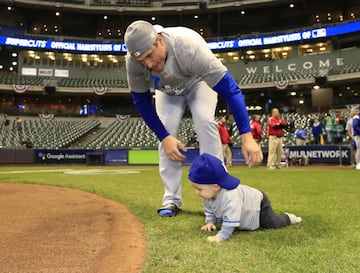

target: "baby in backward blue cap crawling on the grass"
[188,153,302,243]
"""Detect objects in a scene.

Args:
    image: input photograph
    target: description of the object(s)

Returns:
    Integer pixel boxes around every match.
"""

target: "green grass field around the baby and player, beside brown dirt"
[0,166,360,273]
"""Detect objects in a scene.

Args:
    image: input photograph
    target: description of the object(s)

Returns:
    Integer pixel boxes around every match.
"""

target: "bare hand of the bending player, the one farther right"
[241,132,263,167]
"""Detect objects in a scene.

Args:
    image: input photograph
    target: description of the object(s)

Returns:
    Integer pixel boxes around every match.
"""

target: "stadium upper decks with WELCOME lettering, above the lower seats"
[0,0,360,114]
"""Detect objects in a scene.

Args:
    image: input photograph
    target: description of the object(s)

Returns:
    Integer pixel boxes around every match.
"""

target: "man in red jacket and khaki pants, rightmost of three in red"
[267,108,288,170]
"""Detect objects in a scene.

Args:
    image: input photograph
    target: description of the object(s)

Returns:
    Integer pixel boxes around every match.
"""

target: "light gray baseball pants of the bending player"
[155,81,223,208]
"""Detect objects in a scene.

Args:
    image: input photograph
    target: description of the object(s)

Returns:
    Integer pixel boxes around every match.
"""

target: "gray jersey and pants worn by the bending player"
[126,27,227,207]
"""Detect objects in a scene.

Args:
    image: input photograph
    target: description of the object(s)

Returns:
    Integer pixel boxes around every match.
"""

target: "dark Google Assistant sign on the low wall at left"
[35,150,91,164]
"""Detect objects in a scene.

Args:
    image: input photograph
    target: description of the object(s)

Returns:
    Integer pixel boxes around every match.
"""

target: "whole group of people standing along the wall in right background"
[218,108,360,169]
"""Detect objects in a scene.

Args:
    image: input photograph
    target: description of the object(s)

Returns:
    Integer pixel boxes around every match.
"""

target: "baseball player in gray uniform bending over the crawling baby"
[124,20,263,216]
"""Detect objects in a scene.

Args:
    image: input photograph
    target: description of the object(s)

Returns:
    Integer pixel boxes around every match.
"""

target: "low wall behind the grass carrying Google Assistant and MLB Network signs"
[0,145,351,165]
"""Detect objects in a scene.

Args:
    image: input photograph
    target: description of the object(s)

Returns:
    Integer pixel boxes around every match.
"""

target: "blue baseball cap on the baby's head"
[188,153,240,190]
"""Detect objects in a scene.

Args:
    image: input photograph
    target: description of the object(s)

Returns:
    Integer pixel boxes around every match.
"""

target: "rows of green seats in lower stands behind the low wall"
[0,113,349,149]
